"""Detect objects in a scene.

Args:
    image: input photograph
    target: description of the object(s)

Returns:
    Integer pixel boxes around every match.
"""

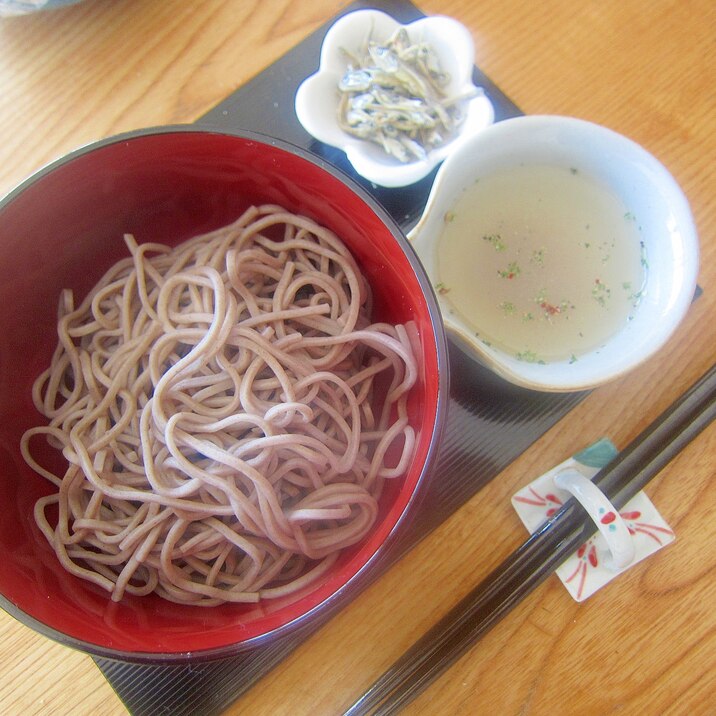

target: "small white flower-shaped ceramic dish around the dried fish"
[296,10,494,187]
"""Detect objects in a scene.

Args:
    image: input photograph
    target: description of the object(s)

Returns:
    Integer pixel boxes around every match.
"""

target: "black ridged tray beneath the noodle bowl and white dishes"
[95,0,585,716]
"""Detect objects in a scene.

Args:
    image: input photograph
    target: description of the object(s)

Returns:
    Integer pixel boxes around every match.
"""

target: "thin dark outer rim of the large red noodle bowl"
[0,124,449,664]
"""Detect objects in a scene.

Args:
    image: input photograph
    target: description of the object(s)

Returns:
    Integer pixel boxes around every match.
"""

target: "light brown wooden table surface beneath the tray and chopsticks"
[0,0,716,716]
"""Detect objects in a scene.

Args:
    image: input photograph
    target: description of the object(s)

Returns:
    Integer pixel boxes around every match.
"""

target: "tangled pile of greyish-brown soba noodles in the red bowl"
[22,206,416,606]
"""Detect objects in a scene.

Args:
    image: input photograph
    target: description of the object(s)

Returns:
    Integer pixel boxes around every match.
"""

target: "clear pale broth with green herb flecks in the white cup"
[436,165,646,362]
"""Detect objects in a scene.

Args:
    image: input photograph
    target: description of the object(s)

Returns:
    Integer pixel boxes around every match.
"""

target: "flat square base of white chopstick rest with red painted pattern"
[512,438,676,602]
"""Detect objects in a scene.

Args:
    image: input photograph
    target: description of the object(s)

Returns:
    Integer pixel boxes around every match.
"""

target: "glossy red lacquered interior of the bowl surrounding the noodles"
[0,127,447,660]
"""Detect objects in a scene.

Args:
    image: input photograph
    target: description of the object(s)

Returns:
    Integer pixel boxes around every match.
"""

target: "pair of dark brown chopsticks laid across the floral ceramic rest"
[344,365,716,716]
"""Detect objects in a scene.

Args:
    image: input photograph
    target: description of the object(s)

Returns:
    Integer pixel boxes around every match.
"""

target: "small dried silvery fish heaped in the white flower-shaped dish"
[338,27,476,162]
